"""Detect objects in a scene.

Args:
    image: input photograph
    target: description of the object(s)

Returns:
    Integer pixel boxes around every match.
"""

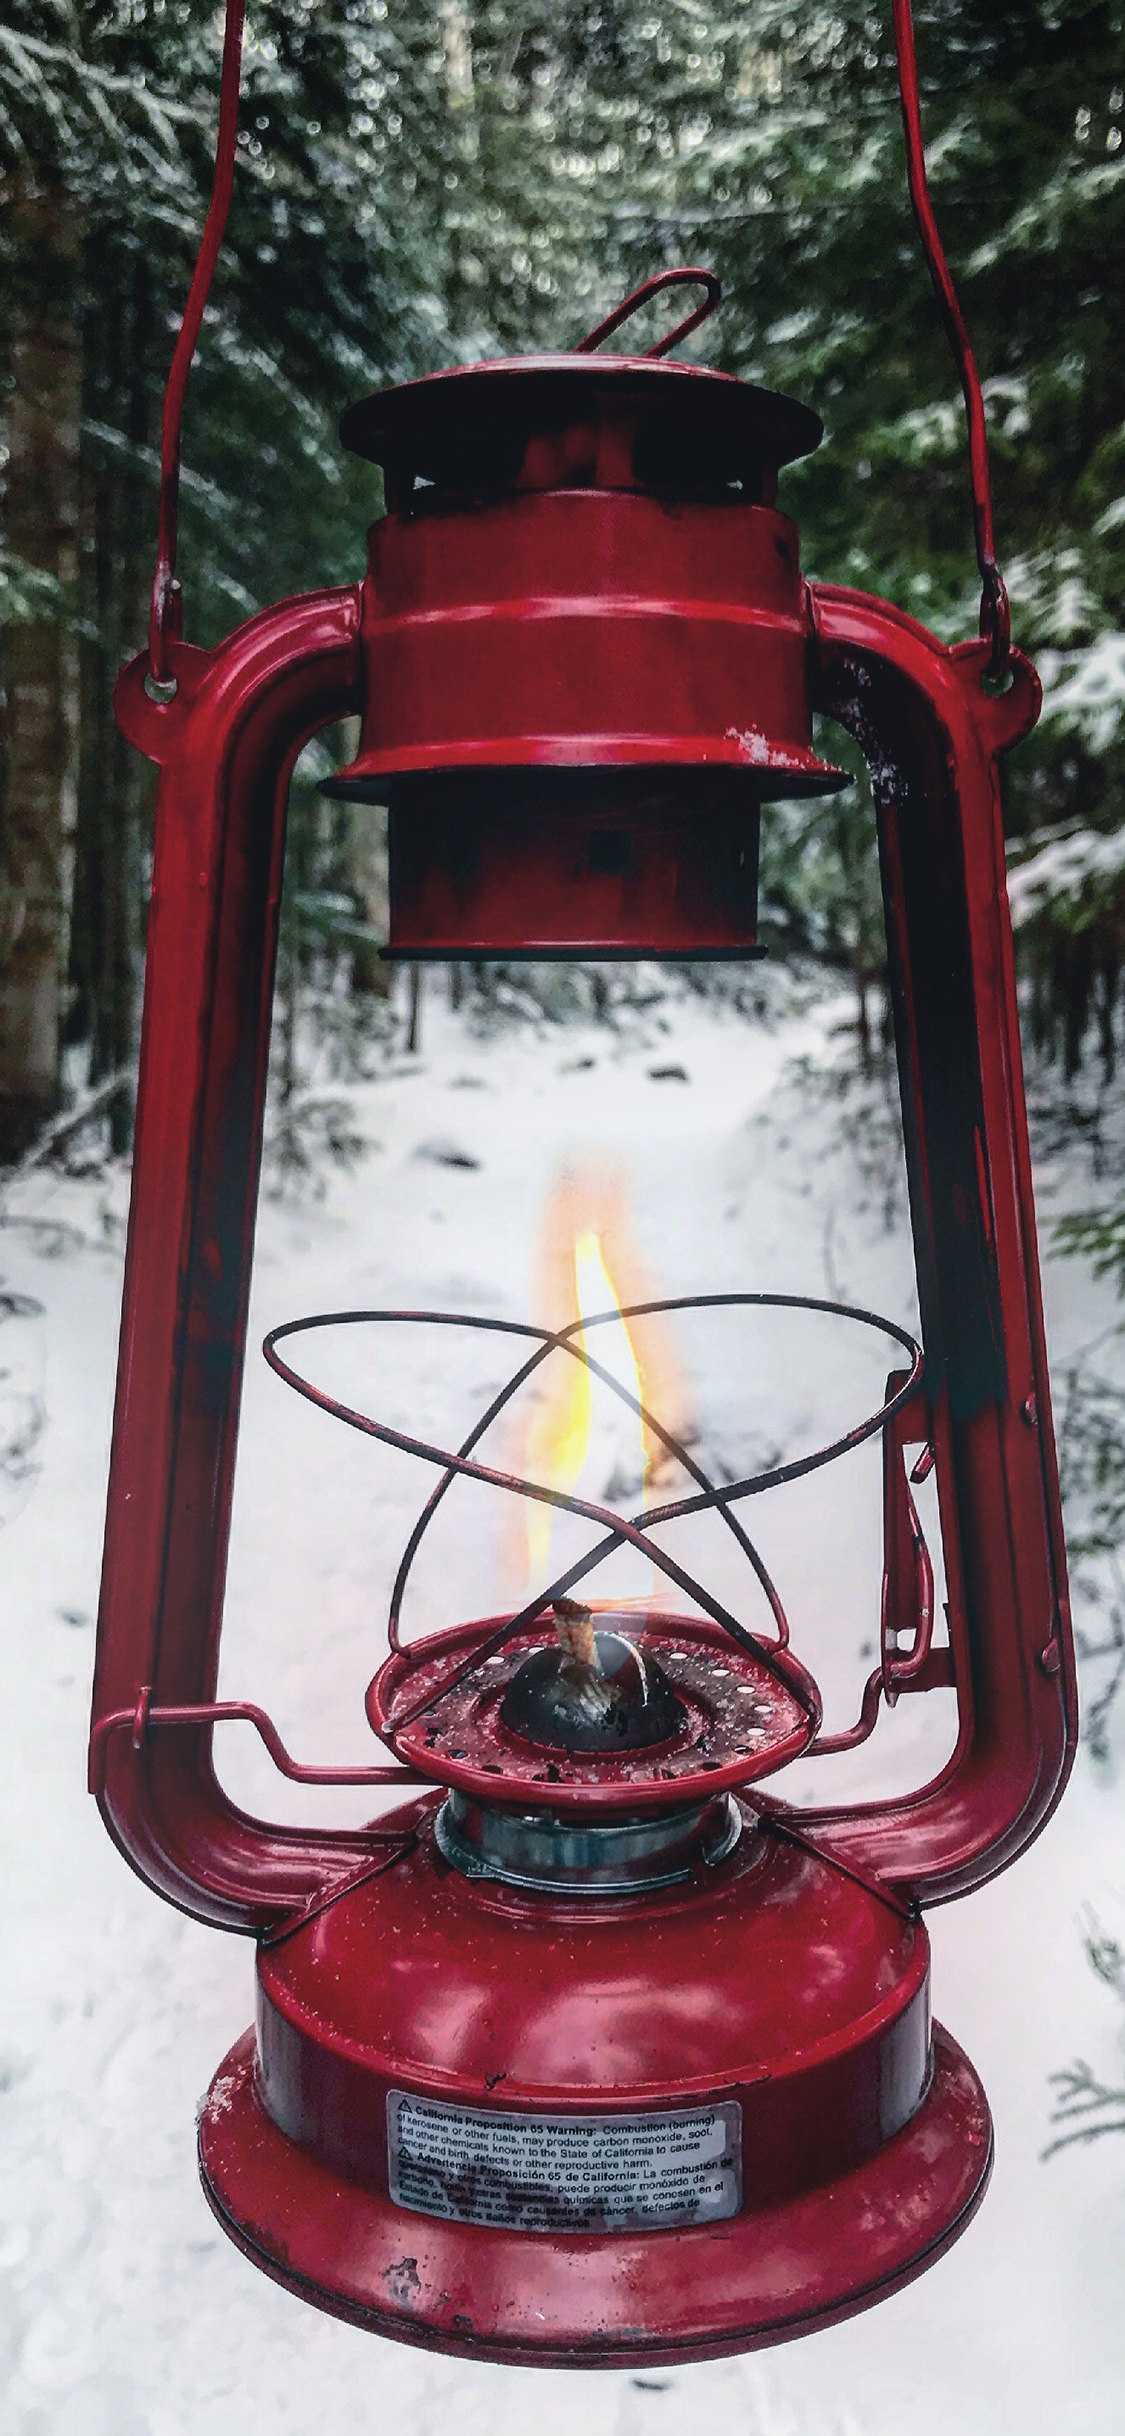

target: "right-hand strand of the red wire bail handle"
[891,0,1011,680]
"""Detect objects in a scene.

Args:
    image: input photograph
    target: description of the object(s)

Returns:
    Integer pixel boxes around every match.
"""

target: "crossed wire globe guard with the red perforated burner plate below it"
[263,1294,923,1812]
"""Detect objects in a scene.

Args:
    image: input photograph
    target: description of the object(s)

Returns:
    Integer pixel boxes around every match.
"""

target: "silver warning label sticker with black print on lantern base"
[387,2090,743,2234]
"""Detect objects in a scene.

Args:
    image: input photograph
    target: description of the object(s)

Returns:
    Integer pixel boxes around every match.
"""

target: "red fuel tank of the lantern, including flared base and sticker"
[200,1798,991,2365]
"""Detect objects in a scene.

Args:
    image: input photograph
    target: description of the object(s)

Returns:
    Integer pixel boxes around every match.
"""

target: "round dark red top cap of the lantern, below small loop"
[341,353,823,480]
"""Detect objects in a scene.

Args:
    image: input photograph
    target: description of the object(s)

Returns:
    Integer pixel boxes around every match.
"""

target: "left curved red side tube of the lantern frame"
[90,585,379,1934]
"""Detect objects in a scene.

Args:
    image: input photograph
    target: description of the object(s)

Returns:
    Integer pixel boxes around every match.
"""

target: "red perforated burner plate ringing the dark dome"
[368,1608,821,1812]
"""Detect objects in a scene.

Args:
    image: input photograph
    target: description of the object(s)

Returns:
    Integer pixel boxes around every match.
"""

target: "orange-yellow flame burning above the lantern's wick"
[511,1167,687,1598]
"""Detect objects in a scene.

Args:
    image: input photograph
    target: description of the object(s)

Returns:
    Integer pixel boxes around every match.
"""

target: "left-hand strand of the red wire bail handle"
[144,0,246,702]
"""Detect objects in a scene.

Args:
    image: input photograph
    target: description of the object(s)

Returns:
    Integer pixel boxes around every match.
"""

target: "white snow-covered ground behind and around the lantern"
[0,1004,1125,2436]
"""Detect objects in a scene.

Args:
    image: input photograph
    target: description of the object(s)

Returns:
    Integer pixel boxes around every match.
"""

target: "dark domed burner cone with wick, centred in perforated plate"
[499,1598,687,1754]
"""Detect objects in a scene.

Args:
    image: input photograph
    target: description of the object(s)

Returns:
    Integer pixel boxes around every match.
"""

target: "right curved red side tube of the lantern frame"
[801,585,1079,1905]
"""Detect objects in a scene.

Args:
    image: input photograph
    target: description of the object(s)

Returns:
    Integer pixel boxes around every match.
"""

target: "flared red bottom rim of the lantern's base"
[200,2022,994,2368]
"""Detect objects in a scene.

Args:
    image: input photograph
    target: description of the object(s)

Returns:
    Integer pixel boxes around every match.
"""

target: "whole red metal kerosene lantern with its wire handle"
[93,0,1074,2365]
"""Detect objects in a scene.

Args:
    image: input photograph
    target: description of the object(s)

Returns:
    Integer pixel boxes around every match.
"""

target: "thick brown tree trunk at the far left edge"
[0,175,80,1160]
